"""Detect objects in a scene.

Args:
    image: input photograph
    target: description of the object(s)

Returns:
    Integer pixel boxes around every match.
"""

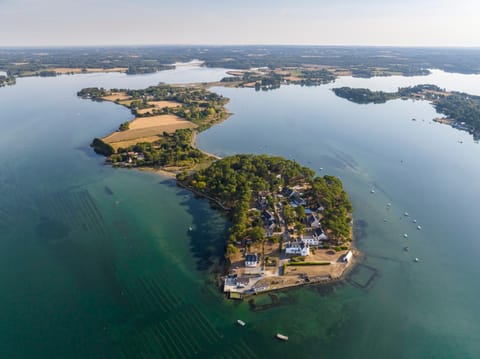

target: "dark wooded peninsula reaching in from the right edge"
[333,85,480,140]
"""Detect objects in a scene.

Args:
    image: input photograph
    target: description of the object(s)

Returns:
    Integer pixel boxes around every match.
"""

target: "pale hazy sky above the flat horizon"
[0,0,480,47]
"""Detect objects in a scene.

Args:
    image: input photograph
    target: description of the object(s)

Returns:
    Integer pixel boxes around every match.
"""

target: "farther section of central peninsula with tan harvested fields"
[77,85,229,173]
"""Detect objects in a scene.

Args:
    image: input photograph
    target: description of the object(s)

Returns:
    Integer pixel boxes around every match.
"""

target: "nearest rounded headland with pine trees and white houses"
[177,155,353,298]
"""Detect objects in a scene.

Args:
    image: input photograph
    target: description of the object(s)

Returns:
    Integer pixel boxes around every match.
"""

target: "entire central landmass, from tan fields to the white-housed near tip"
[78,85,356,298]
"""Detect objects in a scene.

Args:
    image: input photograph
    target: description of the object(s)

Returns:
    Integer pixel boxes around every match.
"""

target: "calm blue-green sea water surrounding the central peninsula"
[0,67,480,358]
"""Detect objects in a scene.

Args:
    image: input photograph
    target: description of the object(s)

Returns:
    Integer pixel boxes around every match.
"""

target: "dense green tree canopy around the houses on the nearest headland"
[177,155,352,257]
